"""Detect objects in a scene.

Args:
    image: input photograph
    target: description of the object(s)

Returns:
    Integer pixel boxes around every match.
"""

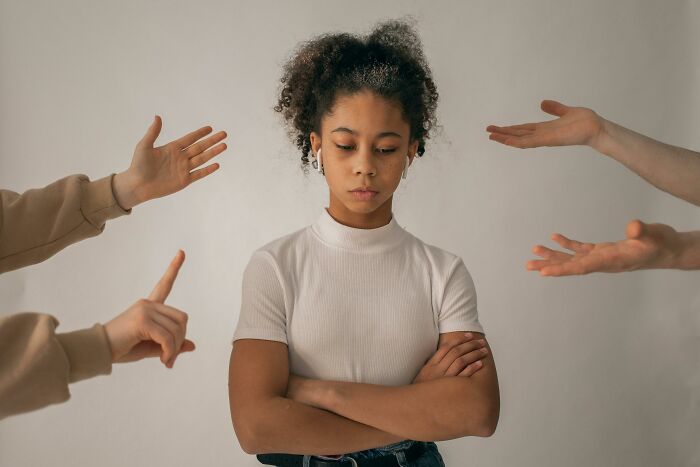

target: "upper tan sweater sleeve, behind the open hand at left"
[0,175,131,273]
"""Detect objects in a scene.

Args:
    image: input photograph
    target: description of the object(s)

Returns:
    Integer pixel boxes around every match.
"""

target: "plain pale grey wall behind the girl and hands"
[0,0,700,467]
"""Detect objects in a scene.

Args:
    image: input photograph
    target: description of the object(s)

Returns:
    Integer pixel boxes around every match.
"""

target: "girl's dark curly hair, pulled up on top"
[274,21,438,168]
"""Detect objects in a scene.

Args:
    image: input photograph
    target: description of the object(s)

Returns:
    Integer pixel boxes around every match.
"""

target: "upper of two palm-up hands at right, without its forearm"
[486,100,603,148]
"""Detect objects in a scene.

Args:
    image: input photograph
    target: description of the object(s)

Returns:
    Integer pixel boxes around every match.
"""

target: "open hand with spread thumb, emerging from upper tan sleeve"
[114,116,226,209]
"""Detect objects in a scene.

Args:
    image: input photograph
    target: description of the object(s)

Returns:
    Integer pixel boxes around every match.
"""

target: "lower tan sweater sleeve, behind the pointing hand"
[0,313,112,420]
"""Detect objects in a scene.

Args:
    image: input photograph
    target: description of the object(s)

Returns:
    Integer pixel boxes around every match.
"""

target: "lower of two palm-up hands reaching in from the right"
[527,220,678,276]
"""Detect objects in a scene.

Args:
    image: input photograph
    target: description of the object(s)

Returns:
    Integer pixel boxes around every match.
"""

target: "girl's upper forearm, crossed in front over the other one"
[295,376,499,441]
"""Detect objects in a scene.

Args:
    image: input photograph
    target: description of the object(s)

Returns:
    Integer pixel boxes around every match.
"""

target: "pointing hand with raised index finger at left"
[105,251,194,368]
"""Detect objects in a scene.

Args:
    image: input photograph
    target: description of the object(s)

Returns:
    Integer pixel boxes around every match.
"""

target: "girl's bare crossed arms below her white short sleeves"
[229,332,500,455]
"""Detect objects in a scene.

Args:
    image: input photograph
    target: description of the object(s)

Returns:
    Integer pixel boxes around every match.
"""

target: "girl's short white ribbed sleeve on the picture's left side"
[233,251,287,344]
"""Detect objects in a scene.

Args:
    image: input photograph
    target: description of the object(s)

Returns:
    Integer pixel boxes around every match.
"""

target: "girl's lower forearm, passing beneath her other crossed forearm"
[233,397,406,455]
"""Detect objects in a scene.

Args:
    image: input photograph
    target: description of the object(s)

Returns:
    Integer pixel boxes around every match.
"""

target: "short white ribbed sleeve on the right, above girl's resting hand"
[438,258,484,334]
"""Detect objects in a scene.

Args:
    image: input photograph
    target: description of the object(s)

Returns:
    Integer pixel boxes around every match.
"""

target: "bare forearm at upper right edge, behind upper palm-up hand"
[591,119,700,206]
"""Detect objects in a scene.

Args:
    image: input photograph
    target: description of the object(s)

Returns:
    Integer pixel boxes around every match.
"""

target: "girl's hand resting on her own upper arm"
[413,332,488,383]
